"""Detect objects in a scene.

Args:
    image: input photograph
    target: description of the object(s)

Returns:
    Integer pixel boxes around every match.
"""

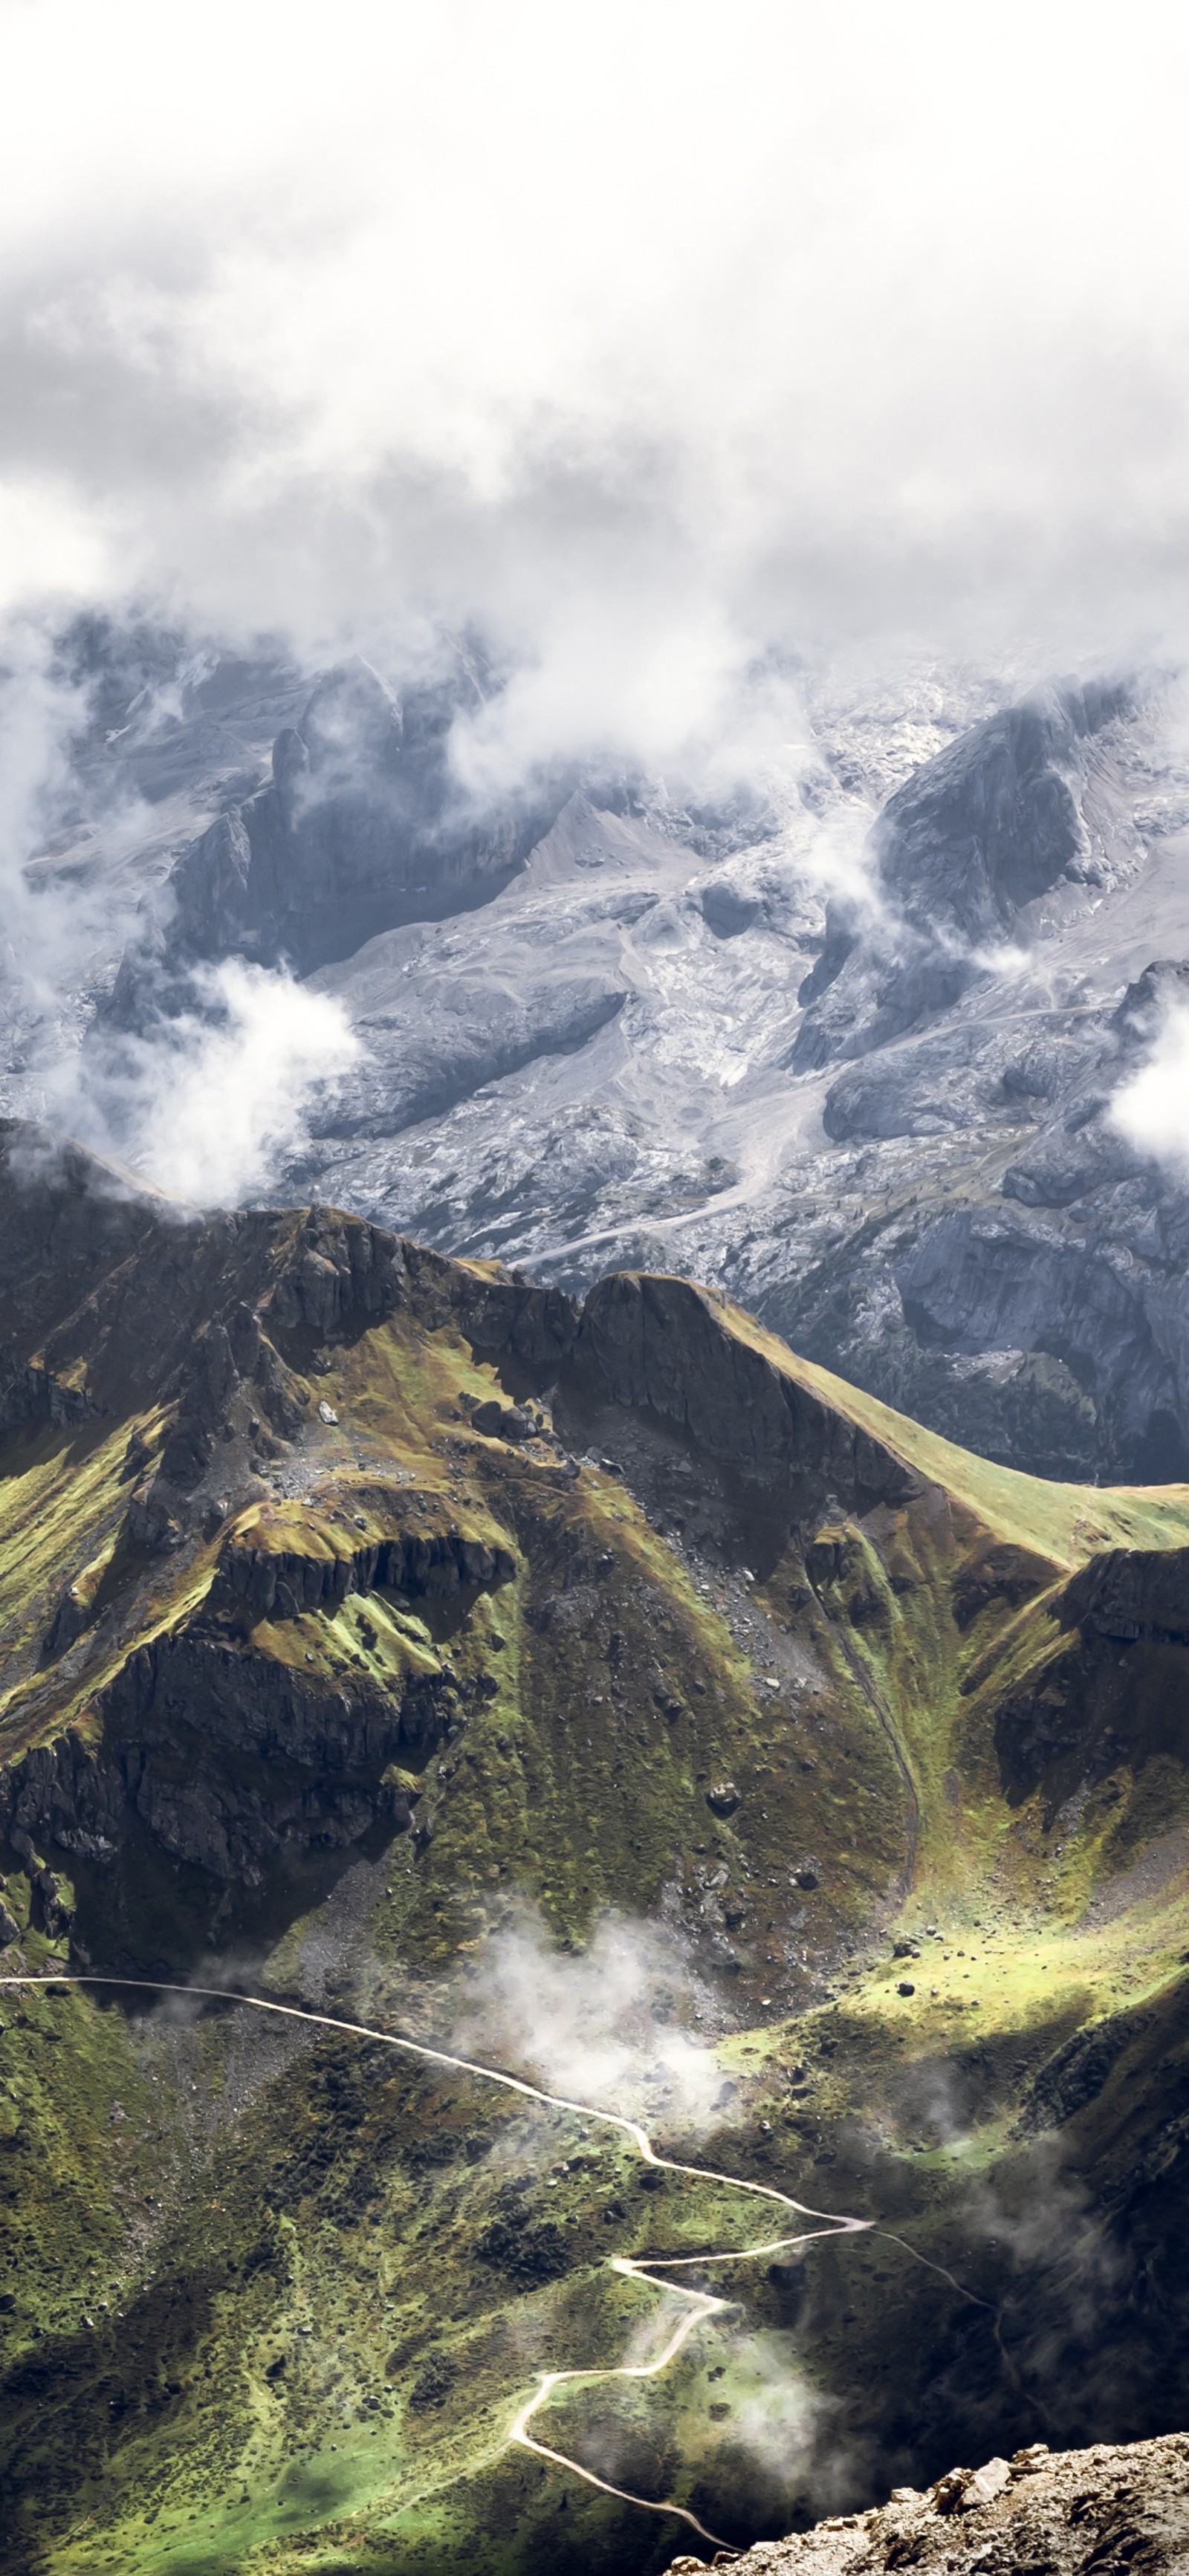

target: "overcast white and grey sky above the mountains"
[0,0,1189,755]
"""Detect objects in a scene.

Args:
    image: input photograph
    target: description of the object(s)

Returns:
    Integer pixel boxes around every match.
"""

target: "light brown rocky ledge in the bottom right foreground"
[668,2434,1189,2576]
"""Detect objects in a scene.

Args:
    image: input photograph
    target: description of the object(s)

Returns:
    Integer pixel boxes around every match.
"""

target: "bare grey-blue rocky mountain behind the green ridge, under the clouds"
[11,623,1189,1482]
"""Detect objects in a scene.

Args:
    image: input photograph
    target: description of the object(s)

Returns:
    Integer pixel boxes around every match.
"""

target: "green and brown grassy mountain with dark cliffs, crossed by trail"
[0,1123,1189,2576]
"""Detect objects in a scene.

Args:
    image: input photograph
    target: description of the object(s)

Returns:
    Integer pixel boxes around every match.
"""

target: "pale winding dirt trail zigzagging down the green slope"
[0,1973,965,2555]
